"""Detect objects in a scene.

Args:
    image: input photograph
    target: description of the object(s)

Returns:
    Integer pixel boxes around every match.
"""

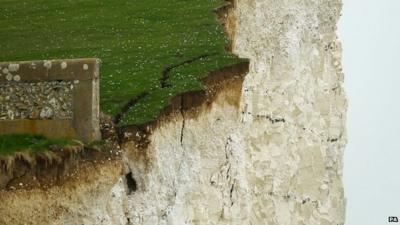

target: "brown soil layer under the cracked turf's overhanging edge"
[117,63,249,149]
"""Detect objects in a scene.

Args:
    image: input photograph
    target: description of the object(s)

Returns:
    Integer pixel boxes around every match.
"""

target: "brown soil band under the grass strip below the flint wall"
[0,145,122,191]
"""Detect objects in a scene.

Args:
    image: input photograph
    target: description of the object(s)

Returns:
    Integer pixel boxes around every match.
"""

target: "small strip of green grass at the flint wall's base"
[0,134,77,156]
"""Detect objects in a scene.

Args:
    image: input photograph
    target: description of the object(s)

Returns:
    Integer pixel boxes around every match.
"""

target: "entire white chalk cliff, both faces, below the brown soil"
[3,0,346,225]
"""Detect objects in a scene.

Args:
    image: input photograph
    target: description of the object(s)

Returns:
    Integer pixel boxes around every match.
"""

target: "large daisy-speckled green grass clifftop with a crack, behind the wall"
[0,0,243,126]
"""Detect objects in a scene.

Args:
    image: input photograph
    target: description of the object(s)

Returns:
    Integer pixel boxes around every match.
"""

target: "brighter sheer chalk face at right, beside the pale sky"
[234,0,346,225]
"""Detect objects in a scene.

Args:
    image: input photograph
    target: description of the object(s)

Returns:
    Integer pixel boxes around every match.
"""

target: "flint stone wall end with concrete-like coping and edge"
[0,59,100,142]
